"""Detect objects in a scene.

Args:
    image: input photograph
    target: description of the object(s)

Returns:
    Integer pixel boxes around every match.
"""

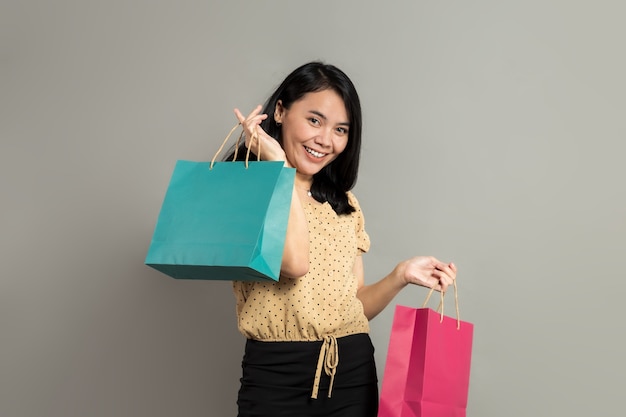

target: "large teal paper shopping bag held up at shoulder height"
[145,161,295,281]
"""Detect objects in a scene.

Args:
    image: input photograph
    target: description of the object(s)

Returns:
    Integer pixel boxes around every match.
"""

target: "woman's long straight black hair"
[225,61,362,214]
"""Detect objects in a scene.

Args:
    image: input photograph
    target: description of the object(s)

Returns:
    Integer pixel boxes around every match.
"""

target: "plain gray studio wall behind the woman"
[0,0,626,417]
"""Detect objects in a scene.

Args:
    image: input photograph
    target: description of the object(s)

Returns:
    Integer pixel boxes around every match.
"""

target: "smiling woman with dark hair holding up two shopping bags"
[231,62,456,417]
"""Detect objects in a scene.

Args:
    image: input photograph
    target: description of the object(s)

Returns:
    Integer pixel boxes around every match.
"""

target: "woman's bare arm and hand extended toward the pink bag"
[354,256,456,320]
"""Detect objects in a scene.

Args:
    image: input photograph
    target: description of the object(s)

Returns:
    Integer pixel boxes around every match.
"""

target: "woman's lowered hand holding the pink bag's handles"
[398,256,457,292]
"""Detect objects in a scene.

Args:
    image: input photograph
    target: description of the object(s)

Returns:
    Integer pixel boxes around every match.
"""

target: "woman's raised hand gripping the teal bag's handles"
[235,105,290,166]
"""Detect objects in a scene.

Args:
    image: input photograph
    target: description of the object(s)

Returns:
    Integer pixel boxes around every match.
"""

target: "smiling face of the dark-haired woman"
[274,90,350,180]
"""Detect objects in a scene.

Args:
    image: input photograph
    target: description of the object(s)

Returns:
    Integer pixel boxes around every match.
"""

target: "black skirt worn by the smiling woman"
[237,334,378,417]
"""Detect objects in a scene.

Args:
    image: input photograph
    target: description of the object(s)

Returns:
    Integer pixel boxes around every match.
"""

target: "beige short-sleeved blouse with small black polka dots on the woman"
[233,192,370,342]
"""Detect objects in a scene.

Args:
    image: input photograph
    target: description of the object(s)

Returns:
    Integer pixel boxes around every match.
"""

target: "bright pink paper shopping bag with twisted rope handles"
[378,286,474,417]
